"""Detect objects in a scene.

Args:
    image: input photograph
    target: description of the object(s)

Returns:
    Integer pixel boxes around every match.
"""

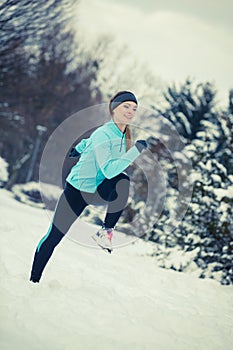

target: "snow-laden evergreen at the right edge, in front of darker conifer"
[176,115,233,284]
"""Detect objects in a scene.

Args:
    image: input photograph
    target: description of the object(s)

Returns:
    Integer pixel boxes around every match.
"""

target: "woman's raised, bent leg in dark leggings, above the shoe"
[97,173,130,228]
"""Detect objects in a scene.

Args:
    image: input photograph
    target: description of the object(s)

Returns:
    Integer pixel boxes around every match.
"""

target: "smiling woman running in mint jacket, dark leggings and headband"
[30,91,147,282]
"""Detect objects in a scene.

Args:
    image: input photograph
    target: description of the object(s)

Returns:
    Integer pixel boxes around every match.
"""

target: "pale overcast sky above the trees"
[74,0,233,105]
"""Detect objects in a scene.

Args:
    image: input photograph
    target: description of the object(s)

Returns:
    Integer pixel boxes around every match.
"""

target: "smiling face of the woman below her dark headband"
[113,101,137,127]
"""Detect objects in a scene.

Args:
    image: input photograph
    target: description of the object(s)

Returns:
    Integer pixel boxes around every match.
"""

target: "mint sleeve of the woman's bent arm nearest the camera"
[92,133,140,179]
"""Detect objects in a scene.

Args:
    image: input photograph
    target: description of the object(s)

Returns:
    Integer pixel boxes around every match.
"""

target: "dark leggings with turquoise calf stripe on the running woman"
[30,173,129,282]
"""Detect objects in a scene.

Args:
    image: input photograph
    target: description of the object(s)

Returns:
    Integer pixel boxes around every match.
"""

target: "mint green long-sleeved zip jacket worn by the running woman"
[66,119,140,193]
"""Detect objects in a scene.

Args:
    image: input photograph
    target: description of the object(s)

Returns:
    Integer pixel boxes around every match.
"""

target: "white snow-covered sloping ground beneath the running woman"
[0,190,233,350]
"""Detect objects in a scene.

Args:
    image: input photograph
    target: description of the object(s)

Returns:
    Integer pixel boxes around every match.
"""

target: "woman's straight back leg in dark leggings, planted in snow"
[30,183,87,282]
